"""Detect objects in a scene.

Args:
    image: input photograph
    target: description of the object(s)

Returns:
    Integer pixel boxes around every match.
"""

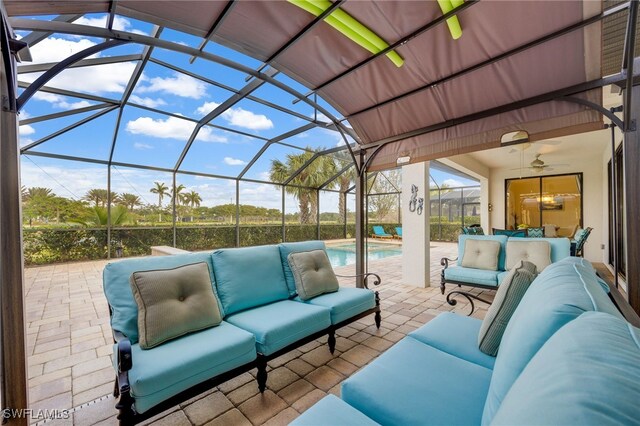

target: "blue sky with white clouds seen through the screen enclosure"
[19,14,470,212]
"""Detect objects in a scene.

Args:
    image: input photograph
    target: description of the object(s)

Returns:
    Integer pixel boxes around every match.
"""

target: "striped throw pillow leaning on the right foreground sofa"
[478,261,536,356]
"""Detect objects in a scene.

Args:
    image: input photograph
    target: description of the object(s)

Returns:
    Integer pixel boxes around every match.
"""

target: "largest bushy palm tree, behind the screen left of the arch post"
[269,147,336,223]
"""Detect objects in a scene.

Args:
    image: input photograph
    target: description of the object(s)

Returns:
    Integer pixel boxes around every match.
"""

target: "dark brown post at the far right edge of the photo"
[623,86,640,314]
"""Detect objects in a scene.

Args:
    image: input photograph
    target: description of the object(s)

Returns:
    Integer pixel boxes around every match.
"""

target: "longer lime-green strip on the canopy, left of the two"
[287,0,404,67]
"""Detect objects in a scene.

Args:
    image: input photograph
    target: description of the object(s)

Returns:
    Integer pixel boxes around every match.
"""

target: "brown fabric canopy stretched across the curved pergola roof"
[5,0,603,169]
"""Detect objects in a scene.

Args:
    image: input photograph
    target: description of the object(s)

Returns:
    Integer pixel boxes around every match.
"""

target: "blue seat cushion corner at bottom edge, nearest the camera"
[289,394,378,426]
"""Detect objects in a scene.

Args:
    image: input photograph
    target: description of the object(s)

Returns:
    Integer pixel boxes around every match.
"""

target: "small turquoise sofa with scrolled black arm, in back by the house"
[440,234,571,315]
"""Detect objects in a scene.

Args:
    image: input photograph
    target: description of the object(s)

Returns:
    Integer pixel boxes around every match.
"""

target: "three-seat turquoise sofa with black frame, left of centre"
[103,241,381,424]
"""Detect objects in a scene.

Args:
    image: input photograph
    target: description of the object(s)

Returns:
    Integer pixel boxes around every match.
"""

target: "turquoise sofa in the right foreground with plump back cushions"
[292,257,640,426]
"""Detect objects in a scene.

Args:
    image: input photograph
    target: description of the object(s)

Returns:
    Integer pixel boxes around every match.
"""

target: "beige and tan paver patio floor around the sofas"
[25,243,492,425]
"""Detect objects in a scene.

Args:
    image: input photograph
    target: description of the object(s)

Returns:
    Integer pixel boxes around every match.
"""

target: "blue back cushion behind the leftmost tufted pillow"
[102,252,219,343]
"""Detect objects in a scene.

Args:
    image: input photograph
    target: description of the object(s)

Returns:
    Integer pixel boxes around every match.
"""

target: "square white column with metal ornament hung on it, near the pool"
[402,162,431,287]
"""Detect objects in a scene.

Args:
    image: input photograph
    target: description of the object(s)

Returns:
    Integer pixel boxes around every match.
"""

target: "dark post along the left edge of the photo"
[0,41,29,425]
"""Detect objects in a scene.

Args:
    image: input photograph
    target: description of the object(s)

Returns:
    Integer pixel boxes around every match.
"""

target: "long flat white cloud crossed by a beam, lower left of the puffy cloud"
[126,117,227,143]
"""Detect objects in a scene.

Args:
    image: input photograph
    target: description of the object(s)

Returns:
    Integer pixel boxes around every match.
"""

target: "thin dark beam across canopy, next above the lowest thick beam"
[345,2,629,120]
